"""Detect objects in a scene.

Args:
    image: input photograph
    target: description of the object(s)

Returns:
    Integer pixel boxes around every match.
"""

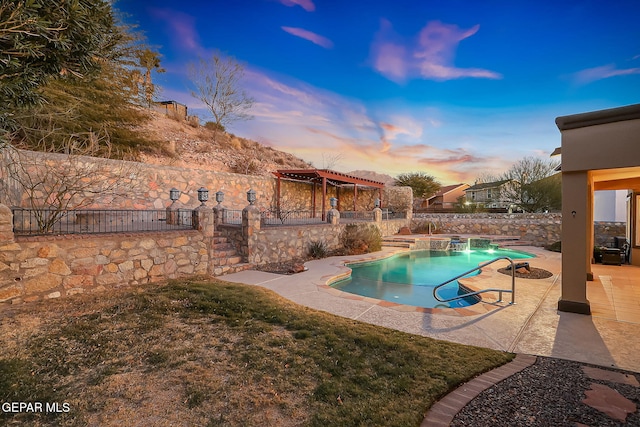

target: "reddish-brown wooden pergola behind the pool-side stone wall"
[273,169,384,221]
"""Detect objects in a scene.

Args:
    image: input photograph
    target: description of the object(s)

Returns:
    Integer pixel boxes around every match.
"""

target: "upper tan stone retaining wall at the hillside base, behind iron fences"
[0,150,413,214]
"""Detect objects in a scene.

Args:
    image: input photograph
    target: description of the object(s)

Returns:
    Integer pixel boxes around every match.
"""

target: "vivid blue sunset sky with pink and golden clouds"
[116,0,640,185]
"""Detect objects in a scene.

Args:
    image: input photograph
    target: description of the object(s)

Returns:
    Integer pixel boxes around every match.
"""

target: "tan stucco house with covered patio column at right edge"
[556,104,640,314]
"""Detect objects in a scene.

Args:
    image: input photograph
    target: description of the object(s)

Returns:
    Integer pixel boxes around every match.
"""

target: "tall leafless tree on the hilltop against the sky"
[189,52,254,141]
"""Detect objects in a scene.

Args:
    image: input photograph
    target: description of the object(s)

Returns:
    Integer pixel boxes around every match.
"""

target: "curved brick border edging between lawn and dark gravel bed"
[420,354,537,427]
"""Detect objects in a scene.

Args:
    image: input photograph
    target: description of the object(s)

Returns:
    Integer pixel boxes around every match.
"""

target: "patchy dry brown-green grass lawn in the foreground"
[0,280,513,426]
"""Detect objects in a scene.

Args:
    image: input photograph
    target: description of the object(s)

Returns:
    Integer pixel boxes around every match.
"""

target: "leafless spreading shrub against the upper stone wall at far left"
[1,134,139,232]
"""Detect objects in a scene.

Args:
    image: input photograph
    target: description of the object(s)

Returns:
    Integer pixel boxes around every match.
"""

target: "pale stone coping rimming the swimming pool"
[317,246,540,317]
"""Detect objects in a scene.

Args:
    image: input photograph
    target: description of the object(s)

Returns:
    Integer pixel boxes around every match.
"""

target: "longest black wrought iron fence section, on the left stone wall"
[12,209,195,236]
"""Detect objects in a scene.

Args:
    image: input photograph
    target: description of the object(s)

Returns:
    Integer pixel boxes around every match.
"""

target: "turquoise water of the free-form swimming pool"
[332,249,532,308]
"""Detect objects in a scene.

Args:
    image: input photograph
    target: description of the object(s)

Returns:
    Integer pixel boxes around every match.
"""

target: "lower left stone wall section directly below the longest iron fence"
[0,230,209,302]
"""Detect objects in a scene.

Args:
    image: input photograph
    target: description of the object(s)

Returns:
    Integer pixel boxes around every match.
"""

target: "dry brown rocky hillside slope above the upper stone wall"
[140,112,311,175]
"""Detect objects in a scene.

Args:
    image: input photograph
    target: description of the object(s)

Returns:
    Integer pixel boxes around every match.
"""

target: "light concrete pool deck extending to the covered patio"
[221,246,640,372]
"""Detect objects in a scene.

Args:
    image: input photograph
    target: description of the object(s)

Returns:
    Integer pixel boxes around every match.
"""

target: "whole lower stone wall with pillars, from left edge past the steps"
[0,204,409,302]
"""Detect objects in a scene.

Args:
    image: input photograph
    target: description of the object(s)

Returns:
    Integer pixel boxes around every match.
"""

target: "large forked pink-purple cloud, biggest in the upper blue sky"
[371,19,502,83]
